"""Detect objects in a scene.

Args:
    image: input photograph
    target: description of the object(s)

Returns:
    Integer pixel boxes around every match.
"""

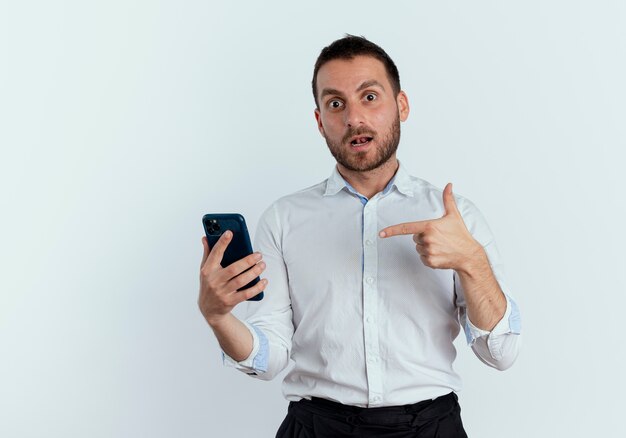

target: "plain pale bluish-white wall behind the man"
[0,0,626,438]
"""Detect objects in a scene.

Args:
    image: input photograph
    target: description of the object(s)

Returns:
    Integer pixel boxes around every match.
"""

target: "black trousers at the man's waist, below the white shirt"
[276,392,467,438]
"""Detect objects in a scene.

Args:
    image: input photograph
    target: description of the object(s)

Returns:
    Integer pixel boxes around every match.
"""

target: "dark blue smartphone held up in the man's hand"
[202,213,263,301]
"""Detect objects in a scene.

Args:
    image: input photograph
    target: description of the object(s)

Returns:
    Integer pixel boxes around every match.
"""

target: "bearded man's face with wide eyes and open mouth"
[315,56,409,172]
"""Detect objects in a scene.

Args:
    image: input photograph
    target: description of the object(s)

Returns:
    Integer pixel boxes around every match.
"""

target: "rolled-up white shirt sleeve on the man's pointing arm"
[454,198,522,370]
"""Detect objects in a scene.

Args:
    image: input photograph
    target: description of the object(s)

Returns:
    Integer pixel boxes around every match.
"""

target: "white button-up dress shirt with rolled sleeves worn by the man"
[223,165,521,407]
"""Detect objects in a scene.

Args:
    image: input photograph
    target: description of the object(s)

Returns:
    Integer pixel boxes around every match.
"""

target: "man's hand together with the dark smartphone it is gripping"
[198,213,267,321]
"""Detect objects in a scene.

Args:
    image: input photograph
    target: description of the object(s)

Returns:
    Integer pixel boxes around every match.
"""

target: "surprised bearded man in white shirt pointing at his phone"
[199,36,520,437]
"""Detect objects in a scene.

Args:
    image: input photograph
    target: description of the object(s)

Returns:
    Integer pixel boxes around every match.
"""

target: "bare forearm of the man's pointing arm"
[457,244,506,331]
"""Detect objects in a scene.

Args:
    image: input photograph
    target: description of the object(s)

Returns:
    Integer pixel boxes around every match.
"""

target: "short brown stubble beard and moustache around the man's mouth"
[325,116,400,172]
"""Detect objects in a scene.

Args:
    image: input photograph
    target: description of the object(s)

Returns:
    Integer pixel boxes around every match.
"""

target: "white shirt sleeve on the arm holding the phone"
[222,204,294,380]
